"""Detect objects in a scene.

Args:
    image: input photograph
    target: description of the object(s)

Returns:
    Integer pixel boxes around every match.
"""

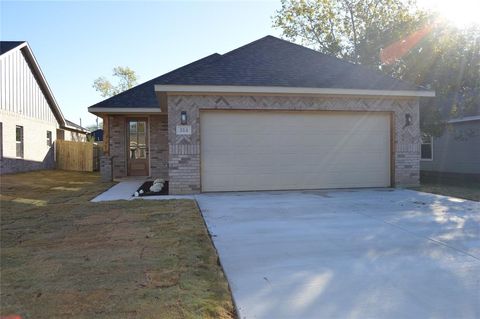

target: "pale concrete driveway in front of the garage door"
[197,189,480,319]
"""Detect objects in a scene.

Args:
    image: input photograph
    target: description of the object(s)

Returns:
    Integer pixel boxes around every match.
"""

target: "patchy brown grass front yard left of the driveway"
[0,171,234,318]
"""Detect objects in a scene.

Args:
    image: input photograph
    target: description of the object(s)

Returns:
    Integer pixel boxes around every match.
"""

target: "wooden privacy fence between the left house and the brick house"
[55,140,94,172]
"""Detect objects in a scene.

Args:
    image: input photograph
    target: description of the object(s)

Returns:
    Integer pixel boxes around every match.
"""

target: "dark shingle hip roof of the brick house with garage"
[88,36,422,107]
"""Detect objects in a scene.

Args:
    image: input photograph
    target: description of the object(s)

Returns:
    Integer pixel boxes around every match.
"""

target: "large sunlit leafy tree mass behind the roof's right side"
[273,0,480,135]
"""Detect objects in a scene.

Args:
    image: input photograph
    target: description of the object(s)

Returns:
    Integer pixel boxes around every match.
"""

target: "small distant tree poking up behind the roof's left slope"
[93,66,137,97]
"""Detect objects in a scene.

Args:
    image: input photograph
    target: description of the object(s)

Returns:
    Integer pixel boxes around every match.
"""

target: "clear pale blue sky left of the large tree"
[0,0,280,126]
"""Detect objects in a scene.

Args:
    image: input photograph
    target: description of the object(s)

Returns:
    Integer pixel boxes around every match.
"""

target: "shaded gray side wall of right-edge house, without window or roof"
[420,121,480,174]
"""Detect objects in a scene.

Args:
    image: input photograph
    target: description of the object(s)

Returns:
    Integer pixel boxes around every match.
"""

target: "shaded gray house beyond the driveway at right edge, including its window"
[420,115,480,180]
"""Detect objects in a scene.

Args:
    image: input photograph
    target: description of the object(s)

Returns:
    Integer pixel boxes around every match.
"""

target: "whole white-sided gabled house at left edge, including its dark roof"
[0,41,88,174]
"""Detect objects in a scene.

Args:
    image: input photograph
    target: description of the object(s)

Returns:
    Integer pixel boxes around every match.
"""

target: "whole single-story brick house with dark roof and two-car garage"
[89,36,434,194]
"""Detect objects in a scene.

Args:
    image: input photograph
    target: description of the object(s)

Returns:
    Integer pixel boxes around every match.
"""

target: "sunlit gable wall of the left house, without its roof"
[0,50,58,174]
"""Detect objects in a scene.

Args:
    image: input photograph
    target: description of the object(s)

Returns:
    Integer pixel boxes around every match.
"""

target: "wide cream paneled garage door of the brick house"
[200,111,390,192]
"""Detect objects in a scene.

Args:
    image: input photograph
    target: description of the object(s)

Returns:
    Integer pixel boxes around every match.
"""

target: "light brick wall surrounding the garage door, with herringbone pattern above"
[168,95,420,194]
